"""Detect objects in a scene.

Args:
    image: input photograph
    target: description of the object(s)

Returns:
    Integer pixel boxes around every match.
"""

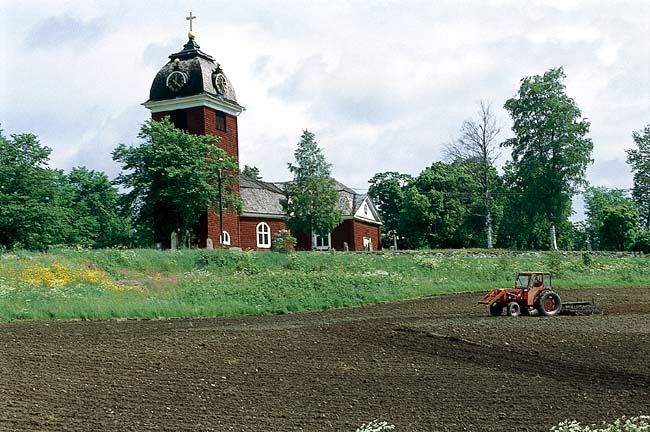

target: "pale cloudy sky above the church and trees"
[0,0,650,218]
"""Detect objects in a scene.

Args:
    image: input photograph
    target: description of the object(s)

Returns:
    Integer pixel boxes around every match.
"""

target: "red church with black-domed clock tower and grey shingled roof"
[143,13,381,251]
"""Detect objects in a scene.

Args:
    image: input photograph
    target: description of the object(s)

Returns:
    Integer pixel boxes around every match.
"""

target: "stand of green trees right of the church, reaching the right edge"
[369,68,650,252]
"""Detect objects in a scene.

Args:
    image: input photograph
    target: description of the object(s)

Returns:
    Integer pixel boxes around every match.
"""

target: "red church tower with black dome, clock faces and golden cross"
[143,12,244,247]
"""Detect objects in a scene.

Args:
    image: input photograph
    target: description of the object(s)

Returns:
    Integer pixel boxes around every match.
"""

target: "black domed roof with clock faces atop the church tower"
[148,35,237,104]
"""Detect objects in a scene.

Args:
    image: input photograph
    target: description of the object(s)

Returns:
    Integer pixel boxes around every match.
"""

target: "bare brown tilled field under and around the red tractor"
[0,288,650,432]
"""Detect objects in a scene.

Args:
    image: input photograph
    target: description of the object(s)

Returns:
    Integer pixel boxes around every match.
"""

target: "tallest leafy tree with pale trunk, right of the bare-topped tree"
[502,67,593,249]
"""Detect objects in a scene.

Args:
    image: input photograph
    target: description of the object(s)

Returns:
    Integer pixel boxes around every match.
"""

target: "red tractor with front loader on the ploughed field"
[479,272,562,316]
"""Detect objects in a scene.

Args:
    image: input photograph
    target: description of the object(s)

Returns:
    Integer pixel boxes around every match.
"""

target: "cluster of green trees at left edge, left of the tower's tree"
[0,130,129,250]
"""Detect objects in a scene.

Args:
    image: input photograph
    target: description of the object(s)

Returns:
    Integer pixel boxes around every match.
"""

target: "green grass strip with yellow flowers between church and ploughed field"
[0,249,650,320]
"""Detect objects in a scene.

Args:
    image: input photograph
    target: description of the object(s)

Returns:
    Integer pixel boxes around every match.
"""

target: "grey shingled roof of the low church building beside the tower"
[239,175,380,221]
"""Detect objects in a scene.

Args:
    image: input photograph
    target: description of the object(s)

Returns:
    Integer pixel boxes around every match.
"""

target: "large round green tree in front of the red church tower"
[113,117,239,244]
